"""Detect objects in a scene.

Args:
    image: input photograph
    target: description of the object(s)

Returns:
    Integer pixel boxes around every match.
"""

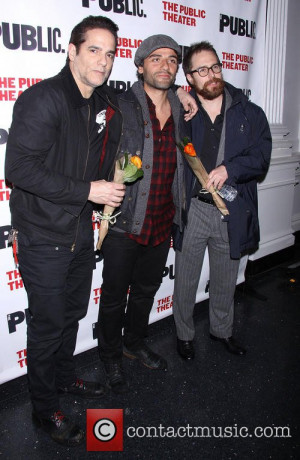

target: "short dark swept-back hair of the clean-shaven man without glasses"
[67,16,119,62]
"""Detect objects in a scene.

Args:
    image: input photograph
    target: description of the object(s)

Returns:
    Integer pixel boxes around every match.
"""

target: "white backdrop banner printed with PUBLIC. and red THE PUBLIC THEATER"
[0,0,266,383]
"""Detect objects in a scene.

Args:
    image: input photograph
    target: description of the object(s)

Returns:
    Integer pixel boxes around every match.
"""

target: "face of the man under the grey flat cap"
[138,48,178,90]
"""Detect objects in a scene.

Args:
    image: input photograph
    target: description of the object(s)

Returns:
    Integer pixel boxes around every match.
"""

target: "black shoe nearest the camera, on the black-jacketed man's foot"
[32,411,84,446]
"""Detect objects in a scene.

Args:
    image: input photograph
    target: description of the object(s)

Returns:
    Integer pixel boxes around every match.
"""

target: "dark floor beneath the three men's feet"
[0,244,300,460]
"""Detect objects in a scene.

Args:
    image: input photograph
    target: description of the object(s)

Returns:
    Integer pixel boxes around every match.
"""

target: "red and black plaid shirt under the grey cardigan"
[129,95,177,246]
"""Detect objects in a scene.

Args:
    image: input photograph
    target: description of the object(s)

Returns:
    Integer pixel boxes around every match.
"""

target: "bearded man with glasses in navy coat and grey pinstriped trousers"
[173,42,272,359]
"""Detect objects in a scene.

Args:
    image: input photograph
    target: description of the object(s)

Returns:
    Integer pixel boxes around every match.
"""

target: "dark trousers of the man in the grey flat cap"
[98,231,170,362]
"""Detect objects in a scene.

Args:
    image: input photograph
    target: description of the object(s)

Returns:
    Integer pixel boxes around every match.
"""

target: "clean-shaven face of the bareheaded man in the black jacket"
[68,29,116,98]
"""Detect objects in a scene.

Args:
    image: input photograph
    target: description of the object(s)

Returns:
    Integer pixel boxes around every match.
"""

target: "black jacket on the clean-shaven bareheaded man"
[5,65,122,248]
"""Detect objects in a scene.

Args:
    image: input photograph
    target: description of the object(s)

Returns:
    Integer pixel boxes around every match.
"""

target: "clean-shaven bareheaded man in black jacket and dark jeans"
[5,16,125,445]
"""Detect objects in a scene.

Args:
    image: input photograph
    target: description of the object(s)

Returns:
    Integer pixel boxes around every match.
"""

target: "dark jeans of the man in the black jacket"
[19,222,95,417]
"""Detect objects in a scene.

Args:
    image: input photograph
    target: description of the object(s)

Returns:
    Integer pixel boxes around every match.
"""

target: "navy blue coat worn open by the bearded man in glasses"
[186,83,272,259]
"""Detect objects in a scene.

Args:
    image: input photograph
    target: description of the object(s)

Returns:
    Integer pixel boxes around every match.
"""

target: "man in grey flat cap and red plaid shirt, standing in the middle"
[98,35,189,393]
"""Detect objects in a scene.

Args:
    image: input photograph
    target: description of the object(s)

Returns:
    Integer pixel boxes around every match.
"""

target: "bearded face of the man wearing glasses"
[186,51,225,100]
